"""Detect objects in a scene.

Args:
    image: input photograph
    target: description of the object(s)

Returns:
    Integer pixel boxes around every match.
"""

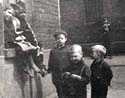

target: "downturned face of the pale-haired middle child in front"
[69,52,82,64]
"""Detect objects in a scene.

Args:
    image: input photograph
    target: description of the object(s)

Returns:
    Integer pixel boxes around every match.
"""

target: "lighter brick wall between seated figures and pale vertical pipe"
[29,0,59,48]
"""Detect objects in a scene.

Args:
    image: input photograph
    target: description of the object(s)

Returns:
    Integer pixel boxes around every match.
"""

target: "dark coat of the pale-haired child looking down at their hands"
[63,60,90,98]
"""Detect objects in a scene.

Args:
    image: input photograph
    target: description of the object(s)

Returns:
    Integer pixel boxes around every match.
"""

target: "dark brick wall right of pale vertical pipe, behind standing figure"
[60,0,125,44]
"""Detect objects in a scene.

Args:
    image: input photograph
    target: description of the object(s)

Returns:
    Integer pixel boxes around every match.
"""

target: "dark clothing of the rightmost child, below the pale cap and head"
[91,61,113,98]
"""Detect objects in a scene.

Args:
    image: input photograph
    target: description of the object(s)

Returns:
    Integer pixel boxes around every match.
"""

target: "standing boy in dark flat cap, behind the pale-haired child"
[48,30,69,98]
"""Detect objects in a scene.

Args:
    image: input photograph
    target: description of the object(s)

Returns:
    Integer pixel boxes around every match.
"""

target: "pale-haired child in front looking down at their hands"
[63,45,90,98]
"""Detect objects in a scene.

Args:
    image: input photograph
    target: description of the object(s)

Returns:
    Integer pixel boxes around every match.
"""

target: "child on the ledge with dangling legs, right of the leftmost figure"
[9,2,40,77]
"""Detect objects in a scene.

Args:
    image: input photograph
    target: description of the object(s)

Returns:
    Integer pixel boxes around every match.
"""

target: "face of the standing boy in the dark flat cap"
[56,34,67,46]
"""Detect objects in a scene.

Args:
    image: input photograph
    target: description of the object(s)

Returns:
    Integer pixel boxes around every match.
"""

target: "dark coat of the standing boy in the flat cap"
[48,46,70,84]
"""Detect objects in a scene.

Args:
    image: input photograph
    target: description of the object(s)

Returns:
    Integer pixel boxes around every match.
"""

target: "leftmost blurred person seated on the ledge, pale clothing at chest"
[4,4,20,48]
